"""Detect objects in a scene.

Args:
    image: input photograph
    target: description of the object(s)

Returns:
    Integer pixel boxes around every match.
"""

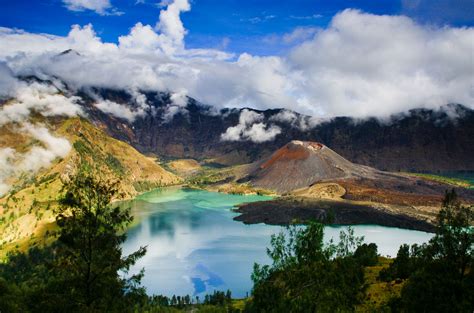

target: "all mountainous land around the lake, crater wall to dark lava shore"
[0,81,474,255]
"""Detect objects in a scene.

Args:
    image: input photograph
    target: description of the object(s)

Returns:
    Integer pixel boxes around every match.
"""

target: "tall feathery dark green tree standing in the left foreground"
[51,175,146,312]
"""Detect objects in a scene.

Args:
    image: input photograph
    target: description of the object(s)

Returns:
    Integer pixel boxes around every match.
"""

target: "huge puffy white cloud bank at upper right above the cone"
[289,10,474,117]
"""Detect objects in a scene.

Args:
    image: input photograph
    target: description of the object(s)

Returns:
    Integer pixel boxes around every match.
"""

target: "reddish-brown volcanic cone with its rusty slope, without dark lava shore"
[249,141,474,206]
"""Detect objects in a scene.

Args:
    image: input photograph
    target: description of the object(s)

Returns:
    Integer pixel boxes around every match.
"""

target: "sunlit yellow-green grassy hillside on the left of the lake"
[0,118,181,255]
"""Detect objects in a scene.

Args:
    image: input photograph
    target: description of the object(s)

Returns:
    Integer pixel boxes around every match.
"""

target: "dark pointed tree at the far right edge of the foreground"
[401,190,474,312]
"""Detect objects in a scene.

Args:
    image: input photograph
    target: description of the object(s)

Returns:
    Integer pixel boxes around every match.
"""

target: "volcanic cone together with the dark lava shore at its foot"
[236,140,474,231]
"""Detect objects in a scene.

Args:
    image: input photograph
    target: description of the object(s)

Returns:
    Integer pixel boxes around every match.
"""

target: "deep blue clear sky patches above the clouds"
[0,0,474,55]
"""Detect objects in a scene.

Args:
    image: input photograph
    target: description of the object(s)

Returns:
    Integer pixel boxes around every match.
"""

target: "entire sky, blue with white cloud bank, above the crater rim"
[0,0,474,117]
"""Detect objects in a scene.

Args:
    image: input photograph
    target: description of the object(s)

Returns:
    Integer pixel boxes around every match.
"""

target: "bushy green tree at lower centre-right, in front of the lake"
[246,223,364,312]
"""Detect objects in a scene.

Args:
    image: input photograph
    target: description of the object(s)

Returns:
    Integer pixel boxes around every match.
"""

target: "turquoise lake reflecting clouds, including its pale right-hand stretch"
[123,188,432,297]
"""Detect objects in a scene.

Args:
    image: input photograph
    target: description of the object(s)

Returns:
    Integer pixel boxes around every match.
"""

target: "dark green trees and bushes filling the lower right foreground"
[246,190,474,312]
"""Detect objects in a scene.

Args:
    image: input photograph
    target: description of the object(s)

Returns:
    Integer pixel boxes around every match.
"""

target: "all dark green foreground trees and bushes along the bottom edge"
[0,174,474,313]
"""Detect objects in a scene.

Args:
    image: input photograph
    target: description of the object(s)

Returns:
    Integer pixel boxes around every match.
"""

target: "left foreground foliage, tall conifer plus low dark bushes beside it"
[0,176,146,312]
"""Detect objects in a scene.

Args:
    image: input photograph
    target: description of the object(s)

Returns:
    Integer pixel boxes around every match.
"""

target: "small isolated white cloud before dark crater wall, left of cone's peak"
[221,109,281,143]
